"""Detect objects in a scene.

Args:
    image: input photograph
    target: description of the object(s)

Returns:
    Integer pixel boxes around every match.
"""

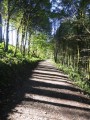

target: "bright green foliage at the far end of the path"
[30,31,51,59]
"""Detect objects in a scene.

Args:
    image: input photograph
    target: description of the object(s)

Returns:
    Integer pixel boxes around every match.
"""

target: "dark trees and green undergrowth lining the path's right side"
[54,0,90,96]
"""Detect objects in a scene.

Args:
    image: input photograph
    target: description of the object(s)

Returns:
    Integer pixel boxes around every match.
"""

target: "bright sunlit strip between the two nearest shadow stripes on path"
[22,94,90,111]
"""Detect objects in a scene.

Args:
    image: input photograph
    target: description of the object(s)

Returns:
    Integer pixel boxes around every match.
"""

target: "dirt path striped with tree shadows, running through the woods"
[0,61,90,120]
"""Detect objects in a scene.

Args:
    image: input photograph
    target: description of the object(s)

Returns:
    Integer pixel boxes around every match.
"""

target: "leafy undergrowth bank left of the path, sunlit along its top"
[0,43,41,88]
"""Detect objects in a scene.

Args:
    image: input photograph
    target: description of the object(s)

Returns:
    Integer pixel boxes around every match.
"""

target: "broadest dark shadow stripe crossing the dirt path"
[23,81,90,104]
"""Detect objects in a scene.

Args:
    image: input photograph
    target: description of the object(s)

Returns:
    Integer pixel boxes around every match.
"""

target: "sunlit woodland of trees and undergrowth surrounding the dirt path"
[0,0,90,117]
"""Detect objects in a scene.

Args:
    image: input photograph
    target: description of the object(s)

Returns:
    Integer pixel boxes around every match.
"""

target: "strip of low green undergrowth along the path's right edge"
[56,64,90,97]
